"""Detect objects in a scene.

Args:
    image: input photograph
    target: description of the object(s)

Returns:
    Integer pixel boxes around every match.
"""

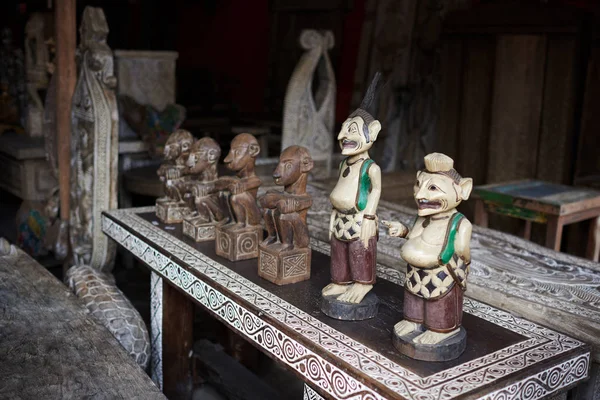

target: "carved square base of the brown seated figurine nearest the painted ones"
[258,246,311,285]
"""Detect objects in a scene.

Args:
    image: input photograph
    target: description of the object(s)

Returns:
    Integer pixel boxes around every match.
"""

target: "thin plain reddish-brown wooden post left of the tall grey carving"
[54,0,77,231]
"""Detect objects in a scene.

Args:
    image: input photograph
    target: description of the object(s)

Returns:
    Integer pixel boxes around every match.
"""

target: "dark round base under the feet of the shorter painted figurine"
[392,327,467,361]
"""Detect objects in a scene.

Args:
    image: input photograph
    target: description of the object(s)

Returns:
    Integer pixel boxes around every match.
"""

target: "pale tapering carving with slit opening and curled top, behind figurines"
[281,29,336,171]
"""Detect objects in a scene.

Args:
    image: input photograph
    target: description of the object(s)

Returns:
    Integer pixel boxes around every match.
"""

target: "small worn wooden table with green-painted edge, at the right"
[473,180,600,261]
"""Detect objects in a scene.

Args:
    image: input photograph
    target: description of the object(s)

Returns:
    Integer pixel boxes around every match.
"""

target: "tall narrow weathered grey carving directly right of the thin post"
[70,7,118,271]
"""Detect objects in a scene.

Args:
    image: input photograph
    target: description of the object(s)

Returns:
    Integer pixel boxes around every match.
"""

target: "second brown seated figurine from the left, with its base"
[183,137,225,242]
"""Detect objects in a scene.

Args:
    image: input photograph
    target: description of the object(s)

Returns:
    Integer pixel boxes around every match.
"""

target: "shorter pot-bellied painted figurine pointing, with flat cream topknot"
[382,153,473,361]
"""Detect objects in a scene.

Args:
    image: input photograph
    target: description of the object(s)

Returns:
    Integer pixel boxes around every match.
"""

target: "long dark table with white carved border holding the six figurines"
[102,206,591,399]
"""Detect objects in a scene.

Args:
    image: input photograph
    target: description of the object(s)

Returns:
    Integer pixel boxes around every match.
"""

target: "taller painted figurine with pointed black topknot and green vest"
[321,74,381,320]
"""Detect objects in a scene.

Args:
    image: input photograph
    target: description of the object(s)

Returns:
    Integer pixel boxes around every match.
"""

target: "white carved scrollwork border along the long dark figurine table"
[103,208,590,399]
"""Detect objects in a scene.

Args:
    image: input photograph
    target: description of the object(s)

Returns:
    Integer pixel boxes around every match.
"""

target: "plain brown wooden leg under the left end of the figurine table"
[162,274,194,399]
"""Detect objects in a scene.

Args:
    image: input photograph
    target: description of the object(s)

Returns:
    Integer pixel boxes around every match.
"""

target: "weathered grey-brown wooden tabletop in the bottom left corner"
[0,244,165,400]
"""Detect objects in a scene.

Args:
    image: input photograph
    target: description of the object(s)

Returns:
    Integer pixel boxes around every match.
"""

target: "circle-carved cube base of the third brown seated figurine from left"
[215,225,263,261]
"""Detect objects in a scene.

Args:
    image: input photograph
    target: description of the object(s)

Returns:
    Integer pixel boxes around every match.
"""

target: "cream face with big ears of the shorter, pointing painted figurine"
[414,171,473,217]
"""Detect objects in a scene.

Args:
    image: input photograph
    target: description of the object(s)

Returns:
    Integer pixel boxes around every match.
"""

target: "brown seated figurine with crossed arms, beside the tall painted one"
[258,146,314,285]
